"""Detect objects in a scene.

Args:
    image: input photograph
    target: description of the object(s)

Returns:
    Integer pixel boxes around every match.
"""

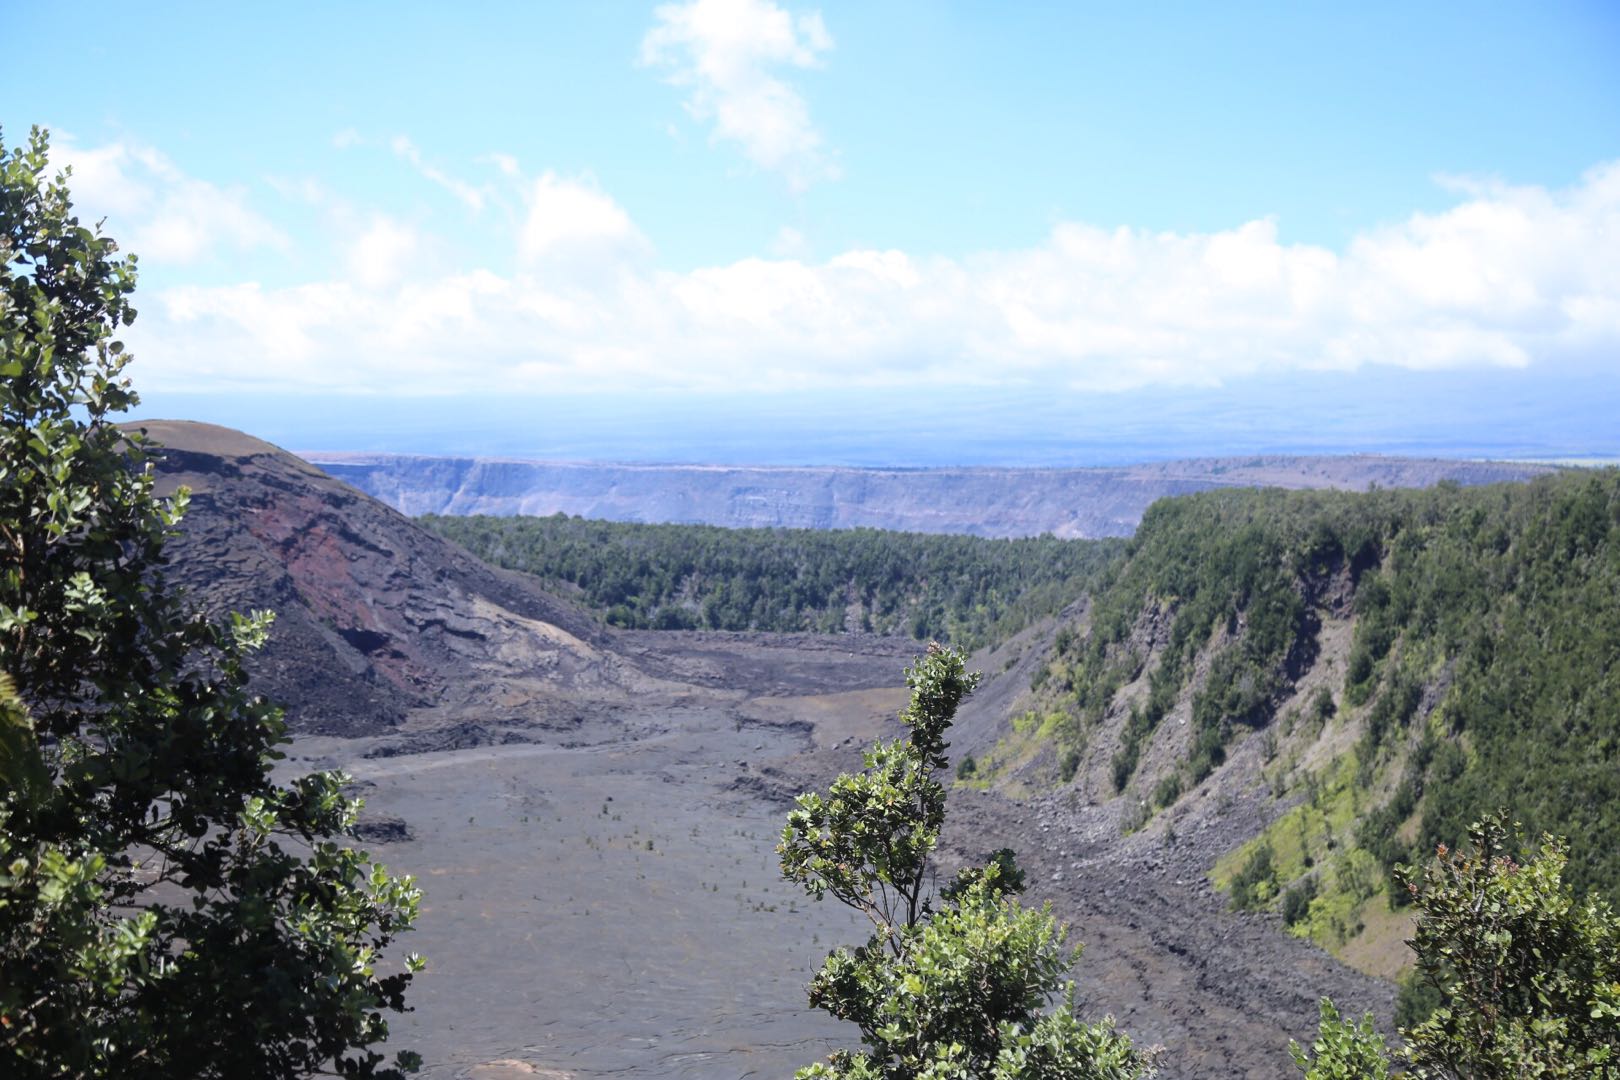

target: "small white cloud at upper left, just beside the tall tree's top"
[52,141,290,264]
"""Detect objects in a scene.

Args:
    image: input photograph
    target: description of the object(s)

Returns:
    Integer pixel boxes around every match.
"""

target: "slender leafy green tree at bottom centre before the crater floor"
[778,644,1150,1080]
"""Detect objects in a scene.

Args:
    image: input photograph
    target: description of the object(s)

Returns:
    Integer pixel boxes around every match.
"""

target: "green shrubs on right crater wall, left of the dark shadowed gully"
[1035,489,1380,793]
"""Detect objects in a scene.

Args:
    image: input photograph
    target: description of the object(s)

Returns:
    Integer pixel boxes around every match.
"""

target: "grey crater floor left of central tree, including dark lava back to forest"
[288,635,904,1078]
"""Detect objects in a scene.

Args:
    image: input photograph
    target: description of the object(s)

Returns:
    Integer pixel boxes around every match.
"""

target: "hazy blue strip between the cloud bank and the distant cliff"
[138,362,1620,468]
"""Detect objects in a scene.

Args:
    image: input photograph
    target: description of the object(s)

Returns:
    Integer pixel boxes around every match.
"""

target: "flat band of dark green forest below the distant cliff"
[420,513,1124,649]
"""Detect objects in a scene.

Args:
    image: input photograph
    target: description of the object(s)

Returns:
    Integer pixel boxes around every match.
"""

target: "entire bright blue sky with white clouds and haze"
[0,0,1620,463]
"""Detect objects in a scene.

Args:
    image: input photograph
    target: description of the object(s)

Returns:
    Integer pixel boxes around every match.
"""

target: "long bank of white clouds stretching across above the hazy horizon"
[75,144,1620,401]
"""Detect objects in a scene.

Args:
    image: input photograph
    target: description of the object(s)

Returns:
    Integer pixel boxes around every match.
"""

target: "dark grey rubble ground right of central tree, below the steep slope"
[946,792,1395,1080]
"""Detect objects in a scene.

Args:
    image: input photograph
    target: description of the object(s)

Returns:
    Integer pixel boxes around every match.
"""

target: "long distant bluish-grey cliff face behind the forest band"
[303,452,1547,538]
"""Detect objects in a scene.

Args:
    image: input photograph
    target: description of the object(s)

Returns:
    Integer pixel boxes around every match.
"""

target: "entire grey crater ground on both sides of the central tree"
[293,635,1392,1078]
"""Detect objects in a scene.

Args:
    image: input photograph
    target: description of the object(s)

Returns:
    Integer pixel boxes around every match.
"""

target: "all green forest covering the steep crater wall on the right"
[1035,470,1620,915]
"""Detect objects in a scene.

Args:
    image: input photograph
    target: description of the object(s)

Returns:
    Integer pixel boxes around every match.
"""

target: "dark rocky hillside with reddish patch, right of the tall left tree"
[139,421,622,733]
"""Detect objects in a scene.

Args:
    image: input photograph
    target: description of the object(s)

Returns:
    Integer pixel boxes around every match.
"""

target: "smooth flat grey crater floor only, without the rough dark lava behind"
[302,712,857,1077]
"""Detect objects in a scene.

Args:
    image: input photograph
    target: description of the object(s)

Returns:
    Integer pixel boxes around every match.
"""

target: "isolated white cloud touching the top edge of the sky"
[642,0,839,191]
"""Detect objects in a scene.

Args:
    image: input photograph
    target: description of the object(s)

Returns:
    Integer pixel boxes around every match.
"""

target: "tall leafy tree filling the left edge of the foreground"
[0,130,418,1080]
